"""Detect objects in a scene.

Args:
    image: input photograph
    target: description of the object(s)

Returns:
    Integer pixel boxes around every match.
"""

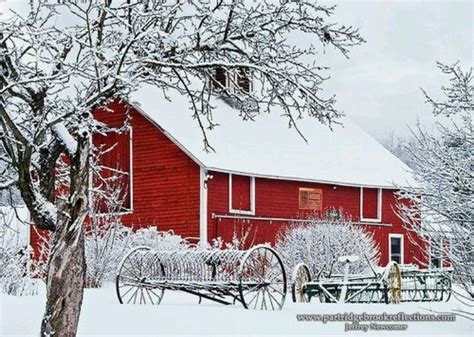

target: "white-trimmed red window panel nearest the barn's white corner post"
[229,174,255,214]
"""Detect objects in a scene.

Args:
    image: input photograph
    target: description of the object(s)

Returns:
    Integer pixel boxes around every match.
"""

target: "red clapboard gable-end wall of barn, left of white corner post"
[95,103,199,237]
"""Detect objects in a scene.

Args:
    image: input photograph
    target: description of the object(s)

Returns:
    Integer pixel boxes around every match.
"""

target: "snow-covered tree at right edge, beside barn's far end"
[398,63,474,312]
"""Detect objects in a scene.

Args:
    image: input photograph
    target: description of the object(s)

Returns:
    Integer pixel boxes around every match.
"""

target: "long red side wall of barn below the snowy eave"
[207,172,421,265]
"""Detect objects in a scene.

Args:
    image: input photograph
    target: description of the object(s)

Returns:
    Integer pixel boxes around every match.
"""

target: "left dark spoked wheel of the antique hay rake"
[115,247,164,305]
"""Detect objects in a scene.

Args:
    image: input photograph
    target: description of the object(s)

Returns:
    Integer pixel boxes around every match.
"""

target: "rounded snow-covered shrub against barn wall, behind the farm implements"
[275,218,380,276]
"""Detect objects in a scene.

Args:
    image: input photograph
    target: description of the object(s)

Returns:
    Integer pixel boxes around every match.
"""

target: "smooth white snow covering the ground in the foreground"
[0,285,474,337]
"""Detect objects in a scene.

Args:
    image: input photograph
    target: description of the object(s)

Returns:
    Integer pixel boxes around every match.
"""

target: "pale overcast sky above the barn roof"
[0,0,474,138]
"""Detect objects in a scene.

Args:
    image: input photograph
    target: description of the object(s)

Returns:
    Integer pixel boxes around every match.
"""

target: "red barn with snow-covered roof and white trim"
[29,87,420,264]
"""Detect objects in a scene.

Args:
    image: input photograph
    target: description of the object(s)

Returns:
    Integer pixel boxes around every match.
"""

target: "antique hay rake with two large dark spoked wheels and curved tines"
[116,245,286,310]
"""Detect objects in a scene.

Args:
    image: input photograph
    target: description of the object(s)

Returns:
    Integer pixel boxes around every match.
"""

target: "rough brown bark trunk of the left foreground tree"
[41,135,89,337]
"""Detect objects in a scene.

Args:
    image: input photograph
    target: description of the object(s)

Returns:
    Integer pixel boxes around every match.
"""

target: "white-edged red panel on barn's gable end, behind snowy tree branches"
[91,129,133,213]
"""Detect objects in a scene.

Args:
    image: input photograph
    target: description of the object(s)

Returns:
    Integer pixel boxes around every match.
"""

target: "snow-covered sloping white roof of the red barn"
[131,86,412,188]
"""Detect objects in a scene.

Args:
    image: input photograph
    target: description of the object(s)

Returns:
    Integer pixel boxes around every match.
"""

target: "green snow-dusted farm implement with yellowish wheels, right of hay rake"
[292,257,451,304]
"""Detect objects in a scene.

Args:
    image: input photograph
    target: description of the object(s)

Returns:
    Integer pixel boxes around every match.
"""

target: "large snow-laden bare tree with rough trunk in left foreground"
[0,0,363,336]
